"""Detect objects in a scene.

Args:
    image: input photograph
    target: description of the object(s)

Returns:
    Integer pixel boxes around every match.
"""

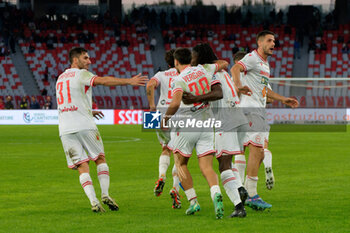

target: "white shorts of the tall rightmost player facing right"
[244,113,268,148]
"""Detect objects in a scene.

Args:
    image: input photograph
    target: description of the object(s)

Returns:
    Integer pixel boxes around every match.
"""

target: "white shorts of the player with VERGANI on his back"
[168,131,215,158]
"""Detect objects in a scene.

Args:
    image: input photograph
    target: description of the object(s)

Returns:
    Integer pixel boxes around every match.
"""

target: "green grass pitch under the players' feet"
[0,126,350,233]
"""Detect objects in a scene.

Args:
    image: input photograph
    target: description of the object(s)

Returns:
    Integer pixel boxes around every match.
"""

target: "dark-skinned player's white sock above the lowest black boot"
[221,169,242,206]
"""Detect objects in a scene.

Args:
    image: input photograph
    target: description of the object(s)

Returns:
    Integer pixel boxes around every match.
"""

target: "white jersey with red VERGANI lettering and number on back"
[173,64,220,118]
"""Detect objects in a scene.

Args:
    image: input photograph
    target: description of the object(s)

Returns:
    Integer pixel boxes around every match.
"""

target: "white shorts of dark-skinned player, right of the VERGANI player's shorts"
[215,124,249,158]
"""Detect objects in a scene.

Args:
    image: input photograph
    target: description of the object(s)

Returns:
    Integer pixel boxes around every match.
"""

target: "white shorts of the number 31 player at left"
[61,130,105,169]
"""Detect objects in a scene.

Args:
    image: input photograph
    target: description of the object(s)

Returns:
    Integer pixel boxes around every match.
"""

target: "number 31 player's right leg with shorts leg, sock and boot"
[80,130,119,210]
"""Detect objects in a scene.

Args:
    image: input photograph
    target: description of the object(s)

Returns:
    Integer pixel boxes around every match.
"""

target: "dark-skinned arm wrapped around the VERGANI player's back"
[182,83,223,104]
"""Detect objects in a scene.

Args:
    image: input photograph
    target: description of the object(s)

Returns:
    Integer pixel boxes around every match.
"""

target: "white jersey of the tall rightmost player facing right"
[238,50,270,108]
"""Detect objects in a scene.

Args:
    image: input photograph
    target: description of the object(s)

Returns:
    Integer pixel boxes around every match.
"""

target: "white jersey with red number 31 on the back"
[56,68,97,135]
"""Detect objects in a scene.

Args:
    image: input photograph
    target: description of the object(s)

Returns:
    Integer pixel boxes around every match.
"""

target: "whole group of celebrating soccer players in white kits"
[56,31,298,219]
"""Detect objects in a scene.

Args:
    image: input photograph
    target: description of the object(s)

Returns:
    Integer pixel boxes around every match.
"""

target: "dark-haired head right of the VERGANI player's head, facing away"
[191,43,218,66]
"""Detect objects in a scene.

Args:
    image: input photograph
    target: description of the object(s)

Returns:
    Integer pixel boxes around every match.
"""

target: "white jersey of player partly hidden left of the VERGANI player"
[151,68,179,113]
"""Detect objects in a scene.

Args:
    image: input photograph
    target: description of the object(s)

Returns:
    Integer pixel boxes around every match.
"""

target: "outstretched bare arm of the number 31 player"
[93,73,148,86]
